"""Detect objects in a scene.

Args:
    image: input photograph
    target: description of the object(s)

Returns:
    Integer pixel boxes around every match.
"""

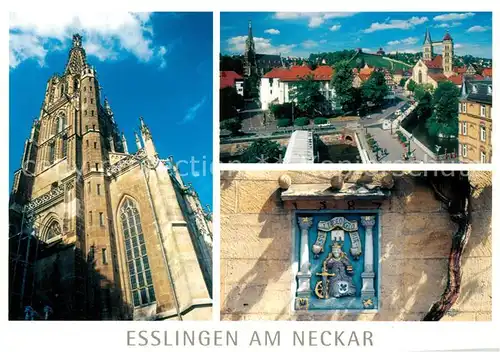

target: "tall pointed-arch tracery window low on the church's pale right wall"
[120,198,156,307]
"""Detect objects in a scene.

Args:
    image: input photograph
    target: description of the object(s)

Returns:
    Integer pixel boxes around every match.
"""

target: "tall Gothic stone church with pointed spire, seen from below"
[9,35,212,320]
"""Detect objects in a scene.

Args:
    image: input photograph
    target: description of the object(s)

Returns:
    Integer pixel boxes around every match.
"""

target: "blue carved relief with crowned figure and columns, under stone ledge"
[281,176,393,313]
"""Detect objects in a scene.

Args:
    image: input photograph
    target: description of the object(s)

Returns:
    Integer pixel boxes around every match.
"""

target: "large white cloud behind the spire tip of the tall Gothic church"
[9,12,166,67]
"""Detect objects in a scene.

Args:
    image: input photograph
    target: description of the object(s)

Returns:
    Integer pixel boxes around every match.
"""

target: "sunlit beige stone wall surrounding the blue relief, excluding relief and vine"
[220,171,492,321]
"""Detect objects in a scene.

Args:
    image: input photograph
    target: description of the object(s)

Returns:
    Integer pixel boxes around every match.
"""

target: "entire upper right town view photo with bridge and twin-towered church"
[220,12,493,163]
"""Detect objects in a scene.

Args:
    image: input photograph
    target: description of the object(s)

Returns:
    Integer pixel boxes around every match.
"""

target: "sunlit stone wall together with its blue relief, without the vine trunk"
[220,171,492,321]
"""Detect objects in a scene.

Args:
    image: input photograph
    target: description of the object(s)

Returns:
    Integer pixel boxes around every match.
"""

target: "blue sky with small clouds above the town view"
[220,12,492,58]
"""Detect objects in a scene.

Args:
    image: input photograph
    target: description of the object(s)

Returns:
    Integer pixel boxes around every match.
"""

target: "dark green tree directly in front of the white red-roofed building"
[290,75,326,116]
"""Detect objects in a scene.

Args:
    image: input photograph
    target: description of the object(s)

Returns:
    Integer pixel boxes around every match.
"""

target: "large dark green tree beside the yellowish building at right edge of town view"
[426,81,460,137]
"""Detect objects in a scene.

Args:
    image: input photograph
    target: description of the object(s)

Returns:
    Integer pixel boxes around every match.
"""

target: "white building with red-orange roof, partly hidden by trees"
[260,66,335,110]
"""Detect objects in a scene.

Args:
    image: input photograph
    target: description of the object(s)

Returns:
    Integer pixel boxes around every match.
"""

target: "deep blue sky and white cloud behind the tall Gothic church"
[9,13,213,206]
